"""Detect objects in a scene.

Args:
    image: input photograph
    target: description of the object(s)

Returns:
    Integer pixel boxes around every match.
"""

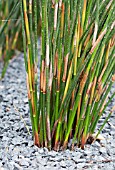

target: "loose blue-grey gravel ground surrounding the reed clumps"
[0,56,115,170]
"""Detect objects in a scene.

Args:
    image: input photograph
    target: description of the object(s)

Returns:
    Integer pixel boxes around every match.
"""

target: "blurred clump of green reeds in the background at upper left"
[0,0,22,78]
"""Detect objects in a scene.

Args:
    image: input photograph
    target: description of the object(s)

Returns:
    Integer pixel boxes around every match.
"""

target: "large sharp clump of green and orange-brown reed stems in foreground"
[20,0,115,151]
